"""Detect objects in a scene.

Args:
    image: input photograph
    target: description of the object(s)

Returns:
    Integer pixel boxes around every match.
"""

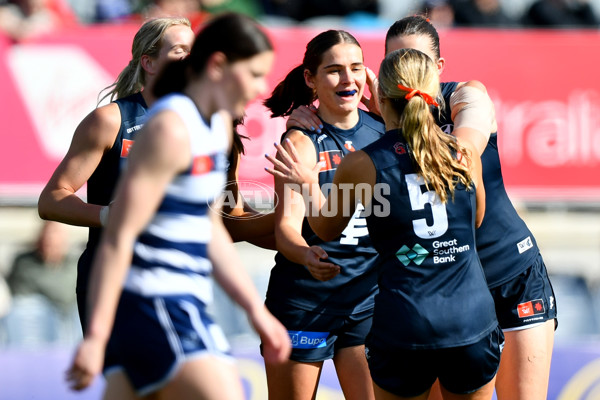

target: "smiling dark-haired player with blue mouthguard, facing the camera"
[258,30,384,400]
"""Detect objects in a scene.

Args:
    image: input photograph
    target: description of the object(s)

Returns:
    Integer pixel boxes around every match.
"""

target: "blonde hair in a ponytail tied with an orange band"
[379,49,472,203]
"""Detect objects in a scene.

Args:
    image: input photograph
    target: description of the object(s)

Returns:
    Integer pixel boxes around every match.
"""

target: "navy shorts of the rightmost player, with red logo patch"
[490,254,556,331]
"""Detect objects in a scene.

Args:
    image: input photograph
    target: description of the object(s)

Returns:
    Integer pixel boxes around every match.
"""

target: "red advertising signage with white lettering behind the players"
[0,25,600,203]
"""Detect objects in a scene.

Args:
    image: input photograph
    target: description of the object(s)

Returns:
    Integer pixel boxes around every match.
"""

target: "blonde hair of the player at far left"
[98,17,191,104]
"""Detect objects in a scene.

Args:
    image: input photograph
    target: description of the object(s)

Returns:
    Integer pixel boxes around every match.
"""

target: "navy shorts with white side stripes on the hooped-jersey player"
[104,291,233,396]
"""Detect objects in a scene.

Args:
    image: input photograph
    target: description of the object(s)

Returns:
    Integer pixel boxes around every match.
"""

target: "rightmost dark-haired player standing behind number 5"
[385,16,557,400]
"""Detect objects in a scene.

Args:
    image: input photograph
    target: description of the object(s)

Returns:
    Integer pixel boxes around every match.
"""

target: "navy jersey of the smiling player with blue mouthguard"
[267,109,385,315]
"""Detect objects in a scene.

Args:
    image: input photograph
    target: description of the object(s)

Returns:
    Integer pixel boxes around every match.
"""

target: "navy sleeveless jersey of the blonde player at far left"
[77,93,148,291]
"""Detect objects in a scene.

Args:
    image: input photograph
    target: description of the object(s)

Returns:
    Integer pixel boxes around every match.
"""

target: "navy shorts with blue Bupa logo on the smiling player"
[261,302,373,362]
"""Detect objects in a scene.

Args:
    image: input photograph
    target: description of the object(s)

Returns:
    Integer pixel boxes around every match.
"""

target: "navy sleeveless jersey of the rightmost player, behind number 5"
[438,82,539,288]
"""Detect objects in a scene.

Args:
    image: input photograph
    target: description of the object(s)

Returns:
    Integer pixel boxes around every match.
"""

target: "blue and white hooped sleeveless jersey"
[125,94,229,304]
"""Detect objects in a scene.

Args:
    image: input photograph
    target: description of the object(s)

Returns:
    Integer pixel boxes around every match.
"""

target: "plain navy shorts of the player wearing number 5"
[365,327,504,397]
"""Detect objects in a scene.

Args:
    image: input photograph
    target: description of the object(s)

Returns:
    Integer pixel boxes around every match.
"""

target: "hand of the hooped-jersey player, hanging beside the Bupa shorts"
[248,304,292,364]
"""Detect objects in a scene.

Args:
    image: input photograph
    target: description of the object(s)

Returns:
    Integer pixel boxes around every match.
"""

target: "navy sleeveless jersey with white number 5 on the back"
[363,130,497,349]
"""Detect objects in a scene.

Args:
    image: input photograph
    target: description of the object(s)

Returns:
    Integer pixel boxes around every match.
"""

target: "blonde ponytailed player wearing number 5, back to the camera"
[269,49,503,400]
